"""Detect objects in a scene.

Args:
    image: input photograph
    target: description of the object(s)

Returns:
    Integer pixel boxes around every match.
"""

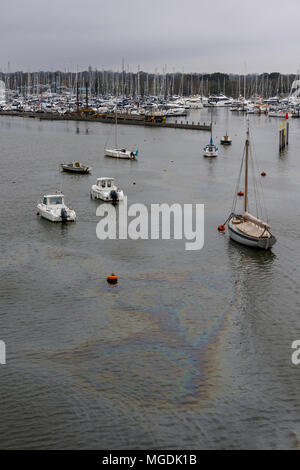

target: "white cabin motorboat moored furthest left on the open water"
[37,193,76,222]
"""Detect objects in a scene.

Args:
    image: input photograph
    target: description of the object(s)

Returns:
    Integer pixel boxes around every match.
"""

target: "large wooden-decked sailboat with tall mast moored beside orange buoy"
[227,127,276,250]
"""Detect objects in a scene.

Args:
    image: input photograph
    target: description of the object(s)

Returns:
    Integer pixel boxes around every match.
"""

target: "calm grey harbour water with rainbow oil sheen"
[0,109,300,449]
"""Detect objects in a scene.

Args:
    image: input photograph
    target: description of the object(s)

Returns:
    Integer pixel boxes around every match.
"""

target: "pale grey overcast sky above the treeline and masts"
[0,0,300,74]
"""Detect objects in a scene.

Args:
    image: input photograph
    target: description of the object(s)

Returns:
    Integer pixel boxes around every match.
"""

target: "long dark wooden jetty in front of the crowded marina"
[0,111,211,131]
